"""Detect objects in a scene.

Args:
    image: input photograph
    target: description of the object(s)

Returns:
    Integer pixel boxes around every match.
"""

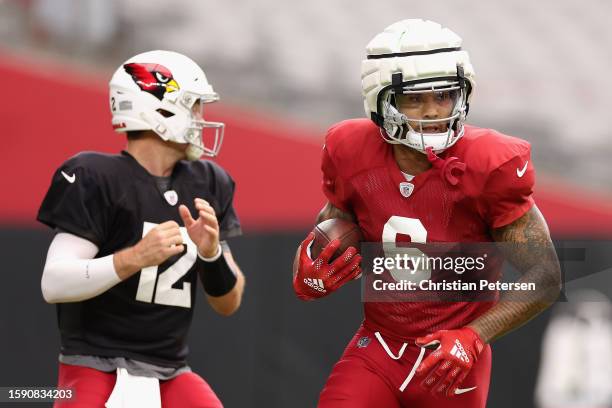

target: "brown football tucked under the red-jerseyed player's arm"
[310,218,363,261]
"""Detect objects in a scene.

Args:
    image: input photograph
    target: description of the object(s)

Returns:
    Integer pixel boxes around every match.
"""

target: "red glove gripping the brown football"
[293,232,361,300]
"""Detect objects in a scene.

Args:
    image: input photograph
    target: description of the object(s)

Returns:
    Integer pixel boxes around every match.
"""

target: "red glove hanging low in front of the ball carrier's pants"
[416,327,484,397]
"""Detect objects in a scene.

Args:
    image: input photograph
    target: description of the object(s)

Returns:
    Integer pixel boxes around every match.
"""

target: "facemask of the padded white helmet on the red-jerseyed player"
[377,73,469,153]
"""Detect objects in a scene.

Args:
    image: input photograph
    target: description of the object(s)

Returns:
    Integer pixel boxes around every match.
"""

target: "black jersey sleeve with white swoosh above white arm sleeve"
[37,154,110,248]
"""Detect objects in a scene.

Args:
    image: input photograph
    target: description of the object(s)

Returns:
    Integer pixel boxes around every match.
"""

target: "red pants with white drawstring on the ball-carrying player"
[318,326,491,408]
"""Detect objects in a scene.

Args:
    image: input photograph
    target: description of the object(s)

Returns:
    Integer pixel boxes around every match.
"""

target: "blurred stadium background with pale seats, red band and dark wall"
[0,0,612,407]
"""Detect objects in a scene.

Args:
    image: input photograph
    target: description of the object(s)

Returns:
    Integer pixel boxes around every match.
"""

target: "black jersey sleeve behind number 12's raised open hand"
[209,166,242,240]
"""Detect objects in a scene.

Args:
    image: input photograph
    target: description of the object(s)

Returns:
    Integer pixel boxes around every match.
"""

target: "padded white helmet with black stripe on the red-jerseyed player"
[361,19,476,153]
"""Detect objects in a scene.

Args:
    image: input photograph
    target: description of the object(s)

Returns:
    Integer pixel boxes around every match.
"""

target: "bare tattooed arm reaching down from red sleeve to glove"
[468,205,561,343]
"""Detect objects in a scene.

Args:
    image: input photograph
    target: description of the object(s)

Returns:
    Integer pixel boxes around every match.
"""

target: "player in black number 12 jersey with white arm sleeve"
[38,51,244,408]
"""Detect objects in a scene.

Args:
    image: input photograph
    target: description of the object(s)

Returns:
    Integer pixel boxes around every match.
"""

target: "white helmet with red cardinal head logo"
[109,51,225,160]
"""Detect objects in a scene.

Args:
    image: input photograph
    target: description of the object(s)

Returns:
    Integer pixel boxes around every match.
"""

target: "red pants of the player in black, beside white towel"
[53,363,223,408]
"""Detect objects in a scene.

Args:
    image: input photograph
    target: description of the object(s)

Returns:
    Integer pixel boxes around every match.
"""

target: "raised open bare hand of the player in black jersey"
[179,198,219,258]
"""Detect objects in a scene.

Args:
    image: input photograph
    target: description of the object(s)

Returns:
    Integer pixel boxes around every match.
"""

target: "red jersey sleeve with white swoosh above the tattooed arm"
[480,143,535,228]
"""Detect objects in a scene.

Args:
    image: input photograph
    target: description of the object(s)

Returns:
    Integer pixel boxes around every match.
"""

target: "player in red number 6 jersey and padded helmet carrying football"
[293,20,560,408]
